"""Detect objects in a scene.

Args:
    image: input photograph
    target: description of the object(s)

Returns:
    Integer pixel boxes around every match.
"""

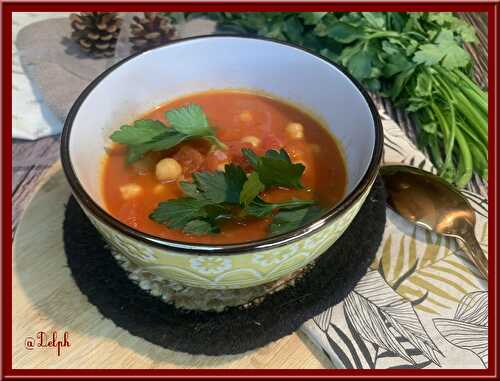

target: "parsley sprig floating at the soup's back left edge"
[110,103,227,164]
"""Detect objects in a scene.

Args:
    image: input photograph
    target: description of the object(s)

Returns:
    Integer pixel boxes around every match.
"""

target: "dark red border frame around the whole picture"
[1,0,500,379]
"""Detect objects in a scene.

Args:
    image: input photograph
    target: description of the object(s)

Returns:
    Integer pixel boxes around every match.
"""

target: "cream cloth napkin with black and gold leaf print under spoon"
[301,110,488,369]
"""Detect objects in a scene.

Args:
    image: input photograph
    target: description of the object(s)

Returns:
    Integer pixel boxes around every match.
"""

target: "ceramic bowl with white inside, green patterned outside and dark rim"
[61,35,383,289]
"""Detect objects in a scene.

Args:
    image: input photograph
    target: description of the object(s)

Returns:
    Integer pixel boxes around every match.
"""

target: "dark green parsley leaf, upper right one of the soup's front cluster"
[242,148,305,189]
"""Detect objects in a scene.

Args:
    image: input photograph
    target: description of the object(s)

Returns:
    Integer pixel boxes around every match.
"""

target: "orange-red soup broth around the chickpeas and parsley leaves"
[101,90,347,244]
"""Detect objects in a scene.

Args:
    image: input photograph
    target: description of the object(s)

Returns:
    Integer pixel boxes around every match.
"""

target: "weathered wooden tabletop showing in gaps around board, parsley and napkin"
[12,13,488,234]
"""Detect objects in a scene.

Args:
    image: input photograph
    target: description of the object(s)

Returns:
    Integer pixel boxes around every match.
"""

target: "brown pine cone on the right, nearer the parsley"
[129,12,175,52]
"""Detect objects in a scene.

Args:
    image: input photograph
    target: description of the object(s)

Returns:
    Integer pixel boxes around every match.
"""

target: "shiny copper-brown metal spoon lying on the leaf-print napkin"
[380,165,488,279]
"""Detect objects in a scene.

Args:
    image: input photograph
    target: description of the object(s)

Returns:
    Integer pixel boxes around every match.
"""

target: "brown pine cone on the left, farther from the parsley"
[69,12,123,58]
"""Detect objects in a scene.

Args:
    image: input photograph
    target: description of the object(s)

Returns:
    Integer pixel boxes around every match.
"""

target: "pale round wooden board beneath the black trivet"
[12,162,329,369]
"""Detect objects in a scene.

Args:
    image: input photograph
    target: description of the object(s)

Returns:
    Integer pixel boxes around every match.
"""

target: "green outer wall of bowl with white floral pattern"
[77,187,371,289]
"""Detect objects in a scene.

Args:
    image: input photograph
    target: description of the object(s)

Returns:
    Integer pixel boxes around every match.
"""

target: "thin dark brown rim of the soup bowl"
[60,33,384,255]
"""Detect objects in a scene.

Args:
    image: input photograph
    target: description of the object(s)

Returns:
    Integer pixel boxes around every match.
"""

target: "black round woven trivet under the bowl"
[64,179,386,355]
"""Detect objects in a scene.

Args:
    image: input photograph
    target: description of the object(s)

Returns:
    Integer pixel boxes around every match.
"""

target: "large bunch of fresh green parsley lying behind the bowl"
[181,12,488,187]
